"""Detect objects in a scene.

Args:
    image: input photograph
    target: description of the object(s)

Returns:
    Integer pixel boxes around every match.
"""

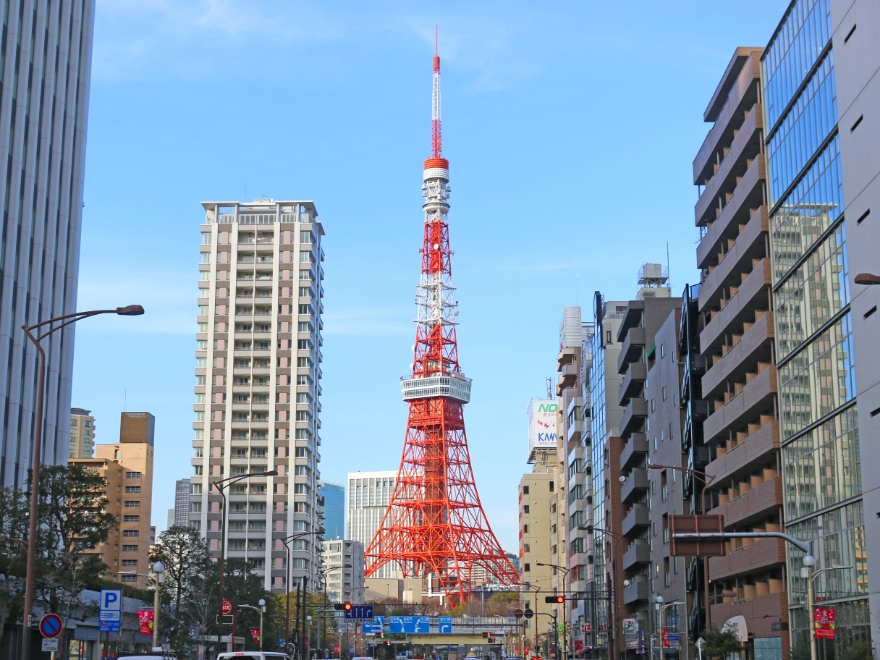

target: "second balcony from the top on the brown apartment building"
[694,105,764,226]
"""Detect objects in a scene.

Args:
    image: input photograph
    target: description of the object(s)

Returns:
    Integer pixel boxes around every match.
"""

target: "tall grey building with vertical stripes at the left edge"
[0,0,95,487]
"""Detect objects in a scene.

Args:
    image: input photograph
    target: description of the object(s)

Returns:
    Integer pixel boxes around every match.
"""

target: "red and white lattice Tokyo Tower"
[366,32,519,607]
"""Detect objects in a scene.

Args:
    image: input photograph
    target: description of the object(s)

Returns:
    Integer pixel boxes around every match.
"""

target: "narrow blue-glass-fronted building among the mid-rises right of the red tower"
[584,291,639,653]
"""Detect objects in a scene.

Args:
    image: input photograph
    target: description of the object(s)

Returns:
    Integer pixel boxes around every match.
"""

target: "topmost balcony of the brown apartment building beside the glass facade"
[693,49,761,184]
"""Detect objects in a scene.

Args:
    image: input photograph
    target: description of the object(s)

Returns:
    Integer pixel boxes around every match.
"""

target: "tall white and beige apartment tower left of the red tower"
[190,199,324,592]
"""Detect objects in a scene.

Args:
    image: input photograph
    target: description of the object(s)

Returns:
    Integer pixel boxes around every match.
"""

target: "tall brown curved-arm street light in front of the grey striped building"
[21,305,144,660]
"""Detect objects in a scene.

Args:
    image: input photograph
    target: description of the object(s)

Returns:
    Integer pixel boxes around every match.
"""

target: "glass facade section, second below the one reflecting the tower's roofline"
[778,314,856,442]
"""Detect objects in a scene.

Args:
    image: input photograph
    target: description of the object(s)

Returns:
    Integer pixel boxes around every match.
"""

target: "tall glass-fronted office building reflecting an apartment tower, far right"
[763,0,870,653]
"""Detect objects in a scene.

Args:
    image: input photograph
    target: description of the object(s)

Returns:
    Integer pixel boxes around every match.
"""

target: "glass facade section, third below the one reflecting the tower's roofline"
[782,406,862,520]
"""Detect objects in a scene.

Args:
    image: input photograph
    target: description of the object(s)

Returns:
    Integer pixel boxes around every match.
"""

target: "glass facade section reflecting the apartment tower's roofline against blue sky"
[770,137,843,285]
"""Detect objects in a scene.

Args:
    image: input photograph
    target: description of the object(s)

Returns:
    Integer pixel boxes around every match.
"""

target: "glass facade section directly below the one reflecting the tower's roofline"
[773,222,849,360]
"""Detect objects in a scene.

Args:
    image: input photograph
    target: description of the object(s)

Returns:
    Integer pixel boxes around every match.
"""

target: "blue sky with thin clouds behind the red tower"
[72,0,788,550]
